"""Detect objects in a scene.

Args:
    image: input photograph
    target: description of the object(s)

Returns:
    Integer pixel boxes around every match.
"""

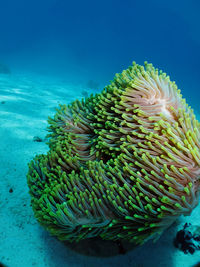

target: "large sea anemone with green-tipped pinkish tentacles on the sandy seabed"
[27,63,200,244]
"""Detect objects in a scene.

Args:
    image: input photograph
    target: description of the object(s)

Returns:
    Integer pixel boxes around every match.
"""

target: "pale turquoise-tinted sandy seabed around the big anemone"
[0,75,200,267]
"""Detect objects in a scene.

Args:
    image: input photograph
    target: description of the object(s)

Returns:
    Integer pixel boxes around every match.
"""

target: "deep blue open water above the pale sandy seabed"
[0,0,200,109]
